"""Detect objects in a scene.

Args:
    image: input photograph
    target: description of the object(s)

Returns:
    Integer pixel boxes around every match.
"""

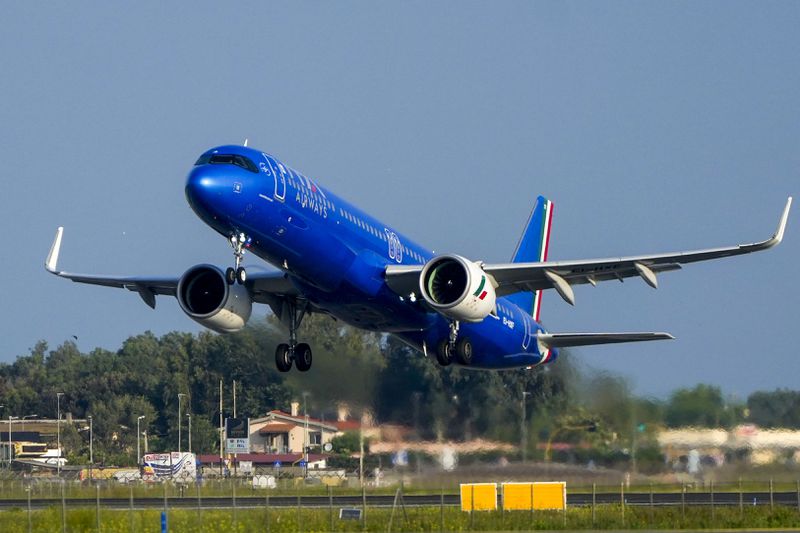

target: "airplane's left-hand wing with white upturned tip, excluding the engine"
[45,227,297,309]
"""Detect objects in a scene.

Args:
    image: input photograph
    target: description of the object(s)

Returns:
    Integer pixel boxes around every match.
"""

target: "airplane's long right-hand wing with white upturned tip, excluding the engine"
[385,196,792,305]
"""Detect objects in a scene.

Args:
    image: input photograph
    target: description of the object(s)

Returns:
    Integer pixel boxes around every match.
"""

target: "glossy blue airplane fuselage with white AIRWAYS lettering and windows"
[186,146,556,369]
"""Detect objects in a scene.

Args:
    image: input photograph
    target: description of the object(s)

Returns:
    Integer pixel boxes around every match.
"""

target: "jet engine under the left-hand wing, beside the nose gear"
[175,265,253,333]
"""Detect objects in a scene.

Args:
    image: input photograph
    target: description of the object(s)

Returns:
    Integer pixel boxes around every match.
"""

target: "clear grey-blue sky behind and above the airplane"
[0,2,800,397]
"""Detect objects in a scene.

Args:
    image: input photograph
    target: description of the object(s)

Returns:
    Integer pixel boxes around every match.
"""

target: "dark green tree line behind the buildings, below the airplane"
[0,315,800,464]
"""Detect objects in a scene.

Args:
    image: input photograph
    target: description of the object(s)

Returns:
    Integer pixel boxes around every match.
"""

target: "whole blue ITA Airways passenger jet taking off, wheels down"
[45,143,792,372]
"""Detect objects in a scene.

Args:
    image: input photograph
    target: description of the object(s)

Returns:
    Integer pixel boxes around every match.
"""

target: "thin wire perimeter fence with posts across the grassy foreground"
[0,478,800,533]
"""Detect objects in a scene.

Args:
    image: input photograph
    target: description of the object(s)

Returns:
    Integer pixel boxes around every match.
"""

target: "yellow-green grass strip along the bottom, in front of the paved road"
[0,505,800,533]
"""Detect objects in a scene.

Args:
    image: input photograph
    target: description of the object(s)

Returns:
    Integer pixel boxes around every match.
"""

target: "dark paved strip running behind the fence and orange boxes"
[0,491,798,509]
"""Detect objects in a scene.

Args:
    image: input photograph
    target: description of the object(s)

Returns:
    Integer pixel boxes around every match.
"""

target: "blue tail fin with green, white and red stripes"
[507,196,553,322]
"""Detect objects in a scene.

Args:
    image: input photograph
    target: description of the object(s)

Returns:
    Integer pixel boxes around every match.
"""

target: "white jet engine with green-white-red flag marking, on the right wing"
[419,255,497,322]
